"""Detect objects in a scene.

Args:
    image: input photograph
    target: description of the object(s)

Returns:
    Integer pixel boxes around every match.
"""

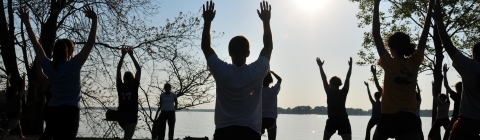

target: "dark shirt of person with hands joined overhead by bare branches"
[117,80,140,112]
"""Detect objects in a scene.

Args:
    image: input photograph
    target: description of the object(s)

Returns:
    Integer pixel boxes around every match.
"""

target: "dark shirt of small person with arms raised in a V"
[327,90,348,118]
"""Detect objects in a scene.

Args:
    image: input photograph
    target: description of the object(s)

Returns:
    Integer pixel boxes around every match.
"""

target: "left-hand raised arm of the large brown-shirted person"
[372,0,387,56]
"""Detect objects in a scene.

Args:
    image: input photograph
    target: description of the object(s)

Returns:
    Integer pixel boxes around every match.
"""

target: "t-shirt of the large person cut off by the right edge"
[452,51,480,119]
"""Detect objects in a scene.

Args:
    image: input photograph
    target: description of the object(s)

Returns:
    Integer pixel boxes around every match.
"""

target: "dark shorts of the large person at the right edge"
[450,116,480,140]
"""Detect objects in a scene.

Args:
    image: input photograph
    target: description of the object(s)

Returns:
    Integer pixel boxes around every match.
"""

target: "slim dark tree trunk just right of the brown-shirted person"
[432,25,448,140]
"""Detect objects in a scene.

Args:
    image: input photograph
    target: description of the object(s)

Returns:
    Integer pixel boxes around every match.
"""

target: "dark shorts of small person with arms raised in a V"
[325,116,352,135]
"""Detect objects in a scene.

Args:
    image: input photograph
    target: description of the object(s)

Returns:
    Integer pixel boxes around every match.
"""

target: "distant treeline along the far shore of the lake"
[277,106,452,117]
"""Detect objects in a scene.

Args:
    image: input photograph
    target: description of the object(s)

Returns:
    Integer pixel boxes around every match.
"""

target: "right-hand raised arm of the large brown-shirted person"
[417,0,435,52]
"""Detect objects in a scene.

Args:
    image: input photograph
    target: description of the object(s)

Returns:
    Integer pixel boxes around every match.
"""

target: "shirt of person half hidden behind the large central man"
[262,82,281,119]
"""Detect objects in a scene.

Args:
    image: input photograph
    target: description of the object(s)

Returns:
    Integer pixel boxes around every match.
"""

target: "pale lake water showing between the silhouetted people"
[77,111,444,140]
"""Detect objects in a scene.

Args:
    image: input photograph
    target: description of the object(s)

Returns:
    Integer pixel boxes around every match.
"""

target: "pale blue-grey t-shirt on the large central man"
[207,54,269,134]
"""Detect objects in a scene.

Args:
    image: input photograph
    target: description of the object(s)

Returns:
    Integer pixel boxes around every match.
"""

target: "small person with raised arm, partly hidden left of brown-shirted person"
[365,80,382,140]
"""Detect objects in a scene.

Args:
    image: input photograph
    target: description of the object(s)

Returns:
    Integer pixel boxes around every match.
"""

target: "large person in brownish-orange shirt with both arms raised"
[372,0,435,140]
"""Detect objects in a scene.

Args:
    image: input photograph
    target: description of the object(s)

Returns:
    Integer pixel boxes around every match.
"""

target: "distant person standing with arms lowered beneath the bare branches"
[154,83,178,140]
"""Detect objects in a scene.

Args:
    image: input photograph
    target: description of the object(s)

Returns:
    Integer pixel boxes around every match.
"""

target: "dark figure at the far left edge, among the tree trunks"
[0,73,25,140]
